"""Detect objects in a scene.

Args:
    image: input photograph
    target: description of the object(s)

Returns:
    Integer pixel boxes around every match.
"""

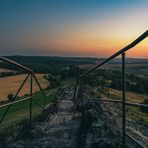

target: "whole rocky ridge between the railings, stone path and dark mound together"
[8,88,143,148]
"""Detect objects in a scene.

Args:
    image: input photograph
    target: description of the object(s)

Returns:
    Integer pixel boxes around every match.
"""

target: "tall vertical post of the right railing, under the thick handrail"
[122,53,126,148]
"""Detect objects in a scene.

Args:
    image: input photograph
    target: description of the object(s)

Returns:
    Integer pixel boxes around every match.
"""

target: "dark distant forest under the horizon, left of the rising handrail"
[0,56,98,73]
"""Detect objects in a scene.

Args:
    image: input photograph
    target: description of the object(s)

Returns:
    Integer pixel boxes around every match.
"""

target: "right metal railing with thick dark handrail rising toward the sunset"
[74,30,148,148]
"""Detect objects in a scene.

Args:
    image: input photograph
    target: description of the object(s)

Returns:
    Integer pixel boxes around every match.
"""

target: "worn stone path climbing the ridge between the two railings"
[9,88,79,148]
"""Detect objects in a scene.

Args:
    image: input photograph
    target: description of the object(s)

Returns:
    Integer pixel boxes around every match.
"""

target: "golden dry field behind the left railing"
[0,74,48,100]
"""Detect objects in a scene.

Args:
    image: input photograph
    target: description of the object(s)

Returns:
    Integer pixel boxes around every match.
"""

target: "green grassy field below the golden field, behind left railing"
[0,88,58,141]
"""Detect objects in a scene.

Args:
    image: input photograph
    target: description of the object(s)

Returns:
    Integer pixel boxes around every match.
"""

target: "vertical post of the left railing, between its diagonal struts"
[29,74,33,127]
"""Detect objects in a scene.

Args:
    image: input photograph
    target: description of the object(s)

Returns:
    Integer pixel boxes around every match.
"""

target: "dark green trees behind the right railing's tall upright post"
[83,69,148,94]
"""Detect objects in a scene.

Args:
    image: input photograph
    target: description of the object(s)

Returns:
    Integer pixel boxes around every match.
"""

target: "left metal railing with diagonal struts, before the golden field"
[0,57,45,127]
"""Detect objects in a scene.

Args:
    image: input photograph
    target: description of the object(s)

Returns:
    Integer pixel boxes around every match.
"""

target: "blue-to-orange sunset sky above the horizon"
[0,0,148,58]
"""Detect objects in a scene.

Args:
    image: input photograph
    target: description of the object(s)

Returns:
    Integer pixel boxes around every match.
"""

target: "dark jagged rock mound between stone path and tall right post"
[77,100,121,148]
